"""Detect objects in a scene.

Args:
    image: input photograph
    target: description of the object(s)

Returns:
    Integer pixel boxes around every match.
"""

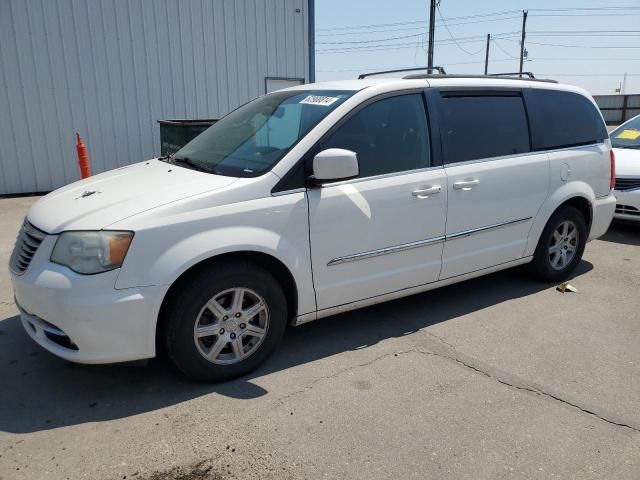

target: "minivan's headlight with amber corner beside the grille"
[51,231,133,274]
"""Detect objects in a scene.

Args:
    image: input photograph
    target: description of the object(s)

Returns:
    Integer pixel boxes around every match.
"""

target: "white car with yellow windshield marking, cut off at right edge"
[611,115,640,222]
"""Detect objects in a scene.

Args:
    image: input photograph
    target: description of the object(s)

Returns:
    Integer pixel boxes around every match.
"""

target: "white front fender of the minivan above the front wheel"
[116,193,316,314]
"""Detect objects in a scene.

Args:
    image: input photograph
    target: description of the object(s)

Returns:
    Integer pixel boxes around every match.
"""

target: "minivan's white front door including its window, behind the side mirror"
[308,91,447,310]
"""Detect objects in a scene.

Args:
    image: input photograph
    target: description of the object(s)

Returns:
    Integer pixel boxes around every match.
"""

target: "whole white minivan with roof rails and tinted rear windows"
[10,75,615,381]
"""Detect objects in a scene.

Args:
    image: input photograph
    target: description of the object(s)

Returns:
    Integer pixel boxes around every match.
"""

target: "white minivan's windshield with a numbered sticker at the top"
[174,90,355,177]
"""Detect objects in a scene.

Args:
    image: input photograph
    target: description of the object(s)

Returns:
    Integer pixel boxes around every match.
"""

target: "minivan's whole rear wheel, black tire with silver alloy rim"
[531,205,588,282]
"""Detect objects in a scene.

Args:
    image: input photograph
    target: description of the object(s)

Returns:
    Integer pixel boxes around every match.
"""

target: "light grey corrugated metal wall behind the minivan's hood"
[0,0,309,194]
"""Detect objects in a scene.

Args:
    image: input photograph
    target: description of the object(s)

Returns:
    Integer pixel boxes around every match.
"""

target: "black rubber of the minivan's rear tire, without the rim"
[533,205,589,282]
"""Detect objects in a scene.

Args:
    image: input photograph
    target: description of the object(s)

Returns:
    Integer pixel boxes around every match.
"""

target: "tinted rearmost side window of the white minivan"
[525,89,608,150]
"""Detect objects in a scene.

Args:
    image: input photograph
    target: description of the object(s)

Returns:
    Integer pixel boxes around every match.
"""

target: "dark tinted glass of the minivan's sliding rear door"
[441,92,531,163]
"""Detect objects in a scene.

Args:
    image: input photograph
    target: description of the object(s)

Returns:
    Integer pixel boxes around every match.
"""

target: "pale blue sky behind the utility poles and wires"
[315,0,640,95]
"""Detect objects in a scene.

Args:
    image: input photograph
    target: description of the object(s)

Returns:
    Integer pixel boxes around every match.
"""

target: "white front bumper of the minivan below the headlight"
[11,236,168,363]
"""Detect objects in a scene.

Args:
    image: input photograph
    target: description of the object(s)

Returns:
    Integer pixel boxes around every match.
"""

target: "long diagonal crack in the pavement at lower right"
[416,330,640,433]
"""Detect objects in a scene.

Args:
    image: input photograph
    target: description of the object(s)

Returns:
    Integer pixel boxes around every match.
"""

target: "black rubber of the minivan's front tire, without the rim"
[163,264,287,382]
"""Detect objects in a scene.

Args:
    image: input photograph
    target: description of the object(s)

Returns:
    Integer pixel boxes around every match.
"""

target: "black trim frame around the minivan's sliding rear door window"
[438,87,535,167]
